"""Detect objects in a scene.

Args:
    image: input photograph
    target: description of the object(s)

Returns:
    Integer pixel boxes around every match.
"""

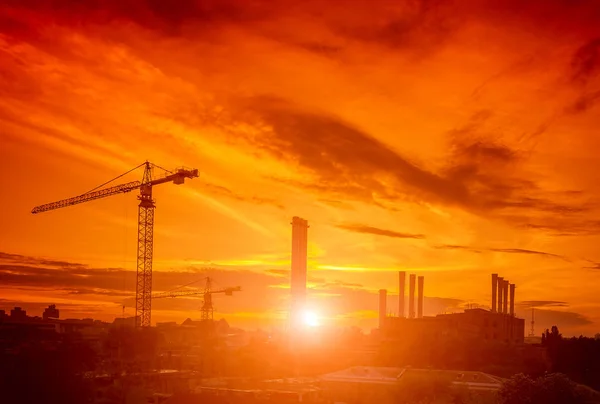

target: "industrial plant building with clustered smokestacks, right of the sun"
[379,272,525,344]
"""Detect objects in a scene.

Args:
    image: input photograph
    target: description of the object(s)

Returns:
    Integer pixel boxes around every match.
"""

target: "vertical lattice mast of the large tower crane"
[135,163,155,327]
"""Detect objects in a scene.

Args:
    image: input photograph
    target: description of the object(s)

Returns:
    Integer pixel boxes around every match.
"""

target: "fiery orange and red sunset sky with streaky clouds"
[0,0,600,335]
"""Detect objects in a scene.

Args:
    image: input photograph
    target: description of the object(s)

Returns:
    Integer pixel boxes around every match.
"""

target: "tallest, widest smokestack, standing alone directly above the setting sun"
[290,216,308,321]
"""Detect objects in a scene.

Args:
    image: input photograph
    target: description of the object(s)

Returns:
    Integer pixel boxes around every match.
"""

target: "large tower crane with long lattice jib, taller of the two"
[31,161,198,327]
